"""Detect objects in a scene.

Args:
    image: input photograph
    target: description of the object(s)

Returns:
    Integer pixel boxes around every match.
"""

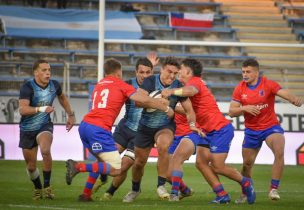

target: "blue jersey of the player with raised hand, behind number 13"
[124,77,143,131]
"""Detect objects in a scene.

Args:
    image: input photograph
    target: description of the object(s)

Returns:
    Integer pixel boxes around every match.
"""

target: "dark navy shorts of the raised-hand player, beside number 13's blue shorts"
[113,118,136,151]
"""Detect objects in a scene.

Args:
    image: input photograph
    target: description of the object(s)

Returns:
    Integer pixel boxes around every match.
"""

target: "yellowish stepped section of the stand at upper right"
[216,0,304,99]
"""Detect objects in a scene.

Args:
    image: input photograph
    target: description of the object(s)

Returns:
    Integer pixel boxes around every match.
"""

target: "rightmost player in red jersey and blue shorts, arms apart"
[229,59,302,203]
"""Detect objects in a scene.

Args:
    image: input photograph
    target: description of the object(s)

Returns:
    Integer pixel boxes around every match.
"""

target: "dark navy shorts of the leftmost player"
[19,122,54,149]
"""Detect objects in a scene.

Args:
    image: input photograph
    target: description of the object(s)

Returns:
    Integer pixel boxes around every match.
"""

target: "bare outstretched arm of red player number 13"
[130,88,174,117]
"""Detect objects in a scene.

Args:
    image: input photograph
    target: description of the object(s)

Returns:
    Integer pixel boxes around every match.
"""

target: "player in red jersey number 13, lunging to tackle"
[66,59,174,201]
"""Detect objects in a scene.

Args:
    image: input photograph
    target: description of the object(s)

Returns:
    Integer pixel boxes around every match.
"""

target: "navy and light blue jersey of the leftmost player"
[19,79,62,131]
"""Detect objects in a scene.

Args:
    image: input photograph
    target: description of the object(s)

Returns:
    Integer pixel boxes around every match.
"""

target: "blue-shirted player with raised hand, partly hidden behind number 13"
[99,56,157,200]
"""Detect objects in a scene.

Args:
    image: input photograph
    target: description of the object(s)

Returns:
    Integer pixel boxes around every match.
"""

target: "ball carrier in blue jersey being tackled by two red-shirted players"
[123,57,198,202]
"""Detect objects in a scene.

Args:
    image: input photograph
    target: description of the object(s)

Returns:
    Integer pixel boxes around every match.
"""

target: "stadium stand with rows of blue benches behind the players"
[0,0,304,101]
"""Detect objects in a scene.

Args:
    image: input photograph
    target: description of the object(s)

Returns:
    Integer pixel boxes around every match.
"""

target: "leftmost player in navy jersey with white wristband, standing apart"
[19,60,75,200]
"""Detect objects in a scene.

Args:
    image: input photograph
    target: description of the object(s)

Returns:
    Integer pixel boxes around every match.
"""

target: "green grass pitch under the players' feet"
[0,160,304,210]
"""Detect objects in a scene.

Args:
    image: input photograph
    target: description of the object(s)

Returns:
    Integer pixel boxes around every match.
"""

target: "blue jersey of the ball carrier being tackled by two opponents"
[140,74,186,128]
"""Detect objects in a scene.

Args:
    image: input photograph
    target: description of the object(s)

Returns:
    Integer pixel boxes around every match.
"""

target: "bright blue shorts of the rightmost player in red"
[243,125,284,149]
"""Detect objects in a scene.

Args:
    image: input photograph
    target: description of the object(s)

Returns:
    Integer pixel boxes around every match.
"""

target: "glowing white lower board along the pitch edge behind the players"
[0,124,304,165]
